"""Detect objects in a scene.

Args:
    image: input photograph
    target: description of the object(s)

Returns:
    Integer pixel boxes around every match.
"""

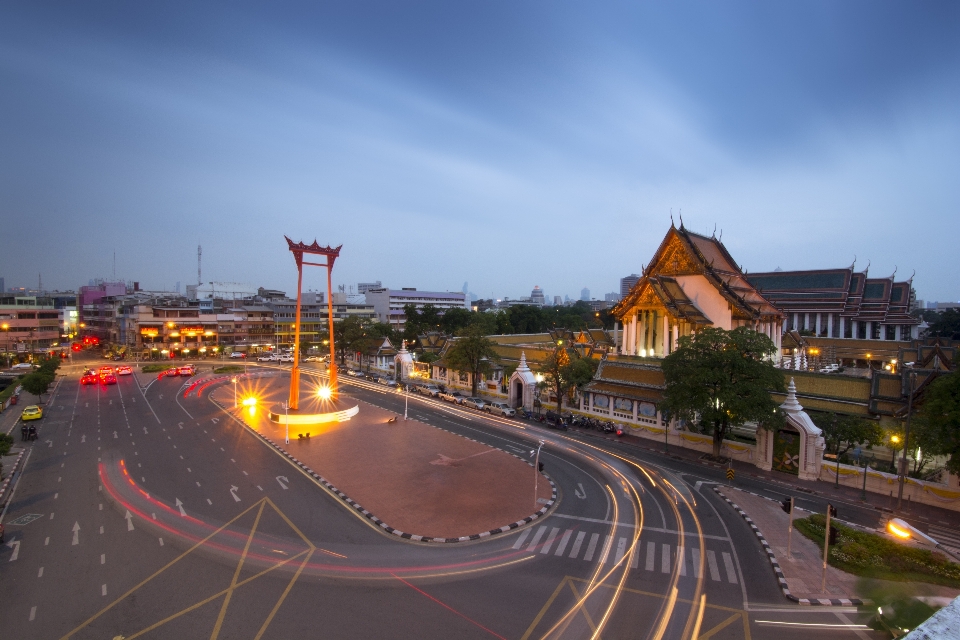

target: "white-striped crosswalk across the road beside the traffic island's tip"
[513,525,739,584]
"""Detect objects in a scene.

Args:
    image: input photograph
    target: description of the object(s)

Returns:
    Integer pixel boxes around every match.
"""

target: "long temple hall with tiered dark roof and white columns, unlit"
[747,265,920,342]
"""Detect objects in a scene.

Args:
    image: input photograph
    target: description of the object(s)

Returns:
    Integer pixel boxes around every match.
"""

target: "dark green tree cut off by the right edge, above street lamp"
[908,371,960,473]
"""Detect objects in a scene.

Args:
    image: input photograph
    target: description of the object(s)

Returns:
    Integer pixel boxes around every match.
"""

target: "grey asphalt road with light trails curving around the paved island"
[0,360,873,638]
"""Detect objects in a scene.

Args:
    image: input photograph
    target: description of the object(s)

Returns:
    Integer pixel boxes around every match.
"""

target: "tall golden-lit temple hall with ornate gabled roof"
[611,223,783,358]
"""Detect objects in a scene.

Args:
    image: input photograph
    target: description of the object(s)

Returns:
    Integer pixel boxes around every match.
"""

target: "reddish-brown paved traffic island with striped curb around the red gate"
[211,375,556,542]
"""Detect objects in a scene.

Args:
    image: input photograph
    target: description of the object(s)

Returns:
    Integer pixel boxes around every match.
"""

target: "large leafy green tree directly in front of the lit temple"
[660,327,784,457]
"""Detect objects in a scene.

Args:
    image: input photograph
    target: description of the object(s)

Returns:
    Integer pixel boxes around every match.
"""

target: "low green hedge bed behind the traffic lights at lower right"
[793,513,960,588]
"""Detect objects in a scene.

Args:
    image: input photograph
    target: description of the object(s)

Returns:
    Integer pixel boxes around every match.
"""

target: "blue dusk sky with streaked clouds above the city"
[0,0,960,301]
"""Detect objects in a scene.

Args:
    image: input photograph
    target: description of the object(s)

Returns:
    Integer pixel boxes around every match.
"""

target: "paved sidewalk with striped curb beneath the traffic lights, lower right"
[717,487,960,605]
